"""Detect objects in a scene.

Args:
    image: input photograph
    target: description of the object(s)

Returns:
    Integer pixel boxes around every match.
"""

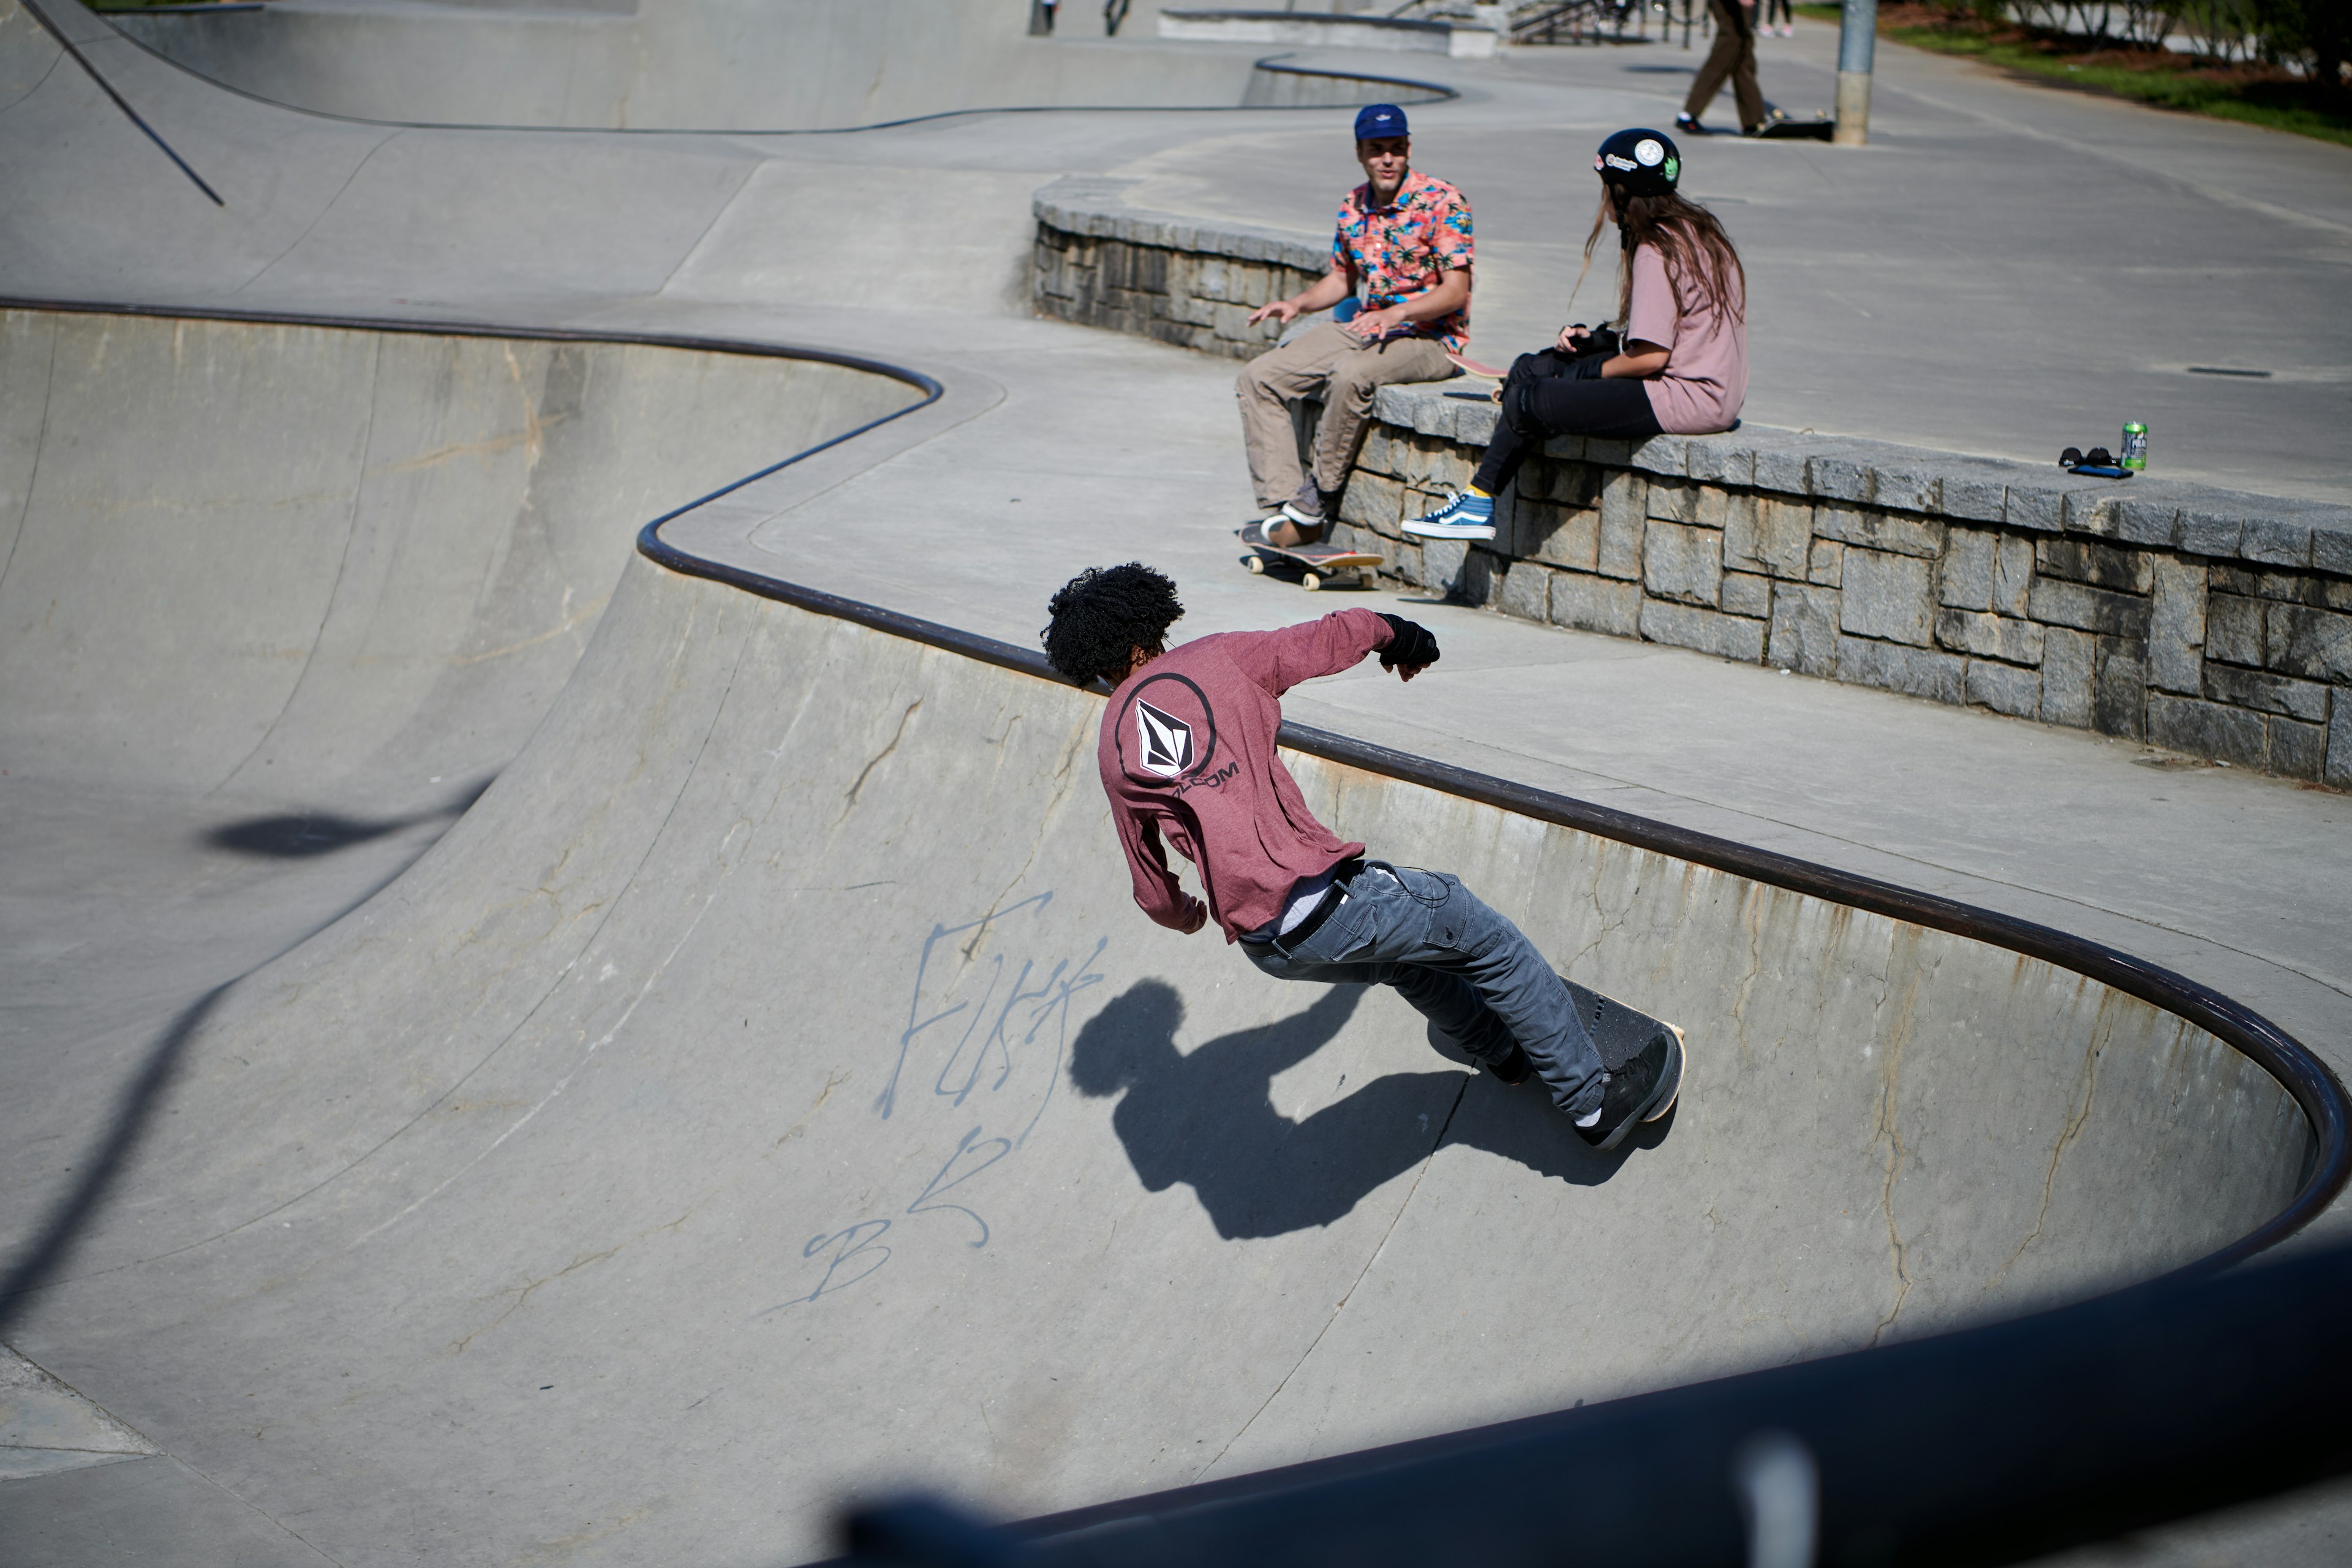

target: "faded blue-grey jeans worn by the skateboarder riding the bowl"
[1242,861,1604,1117]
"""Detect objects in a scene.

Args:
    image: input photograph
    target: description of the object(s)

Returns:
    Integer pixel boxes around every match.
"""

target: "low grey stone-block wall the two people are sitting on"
[1037,181,2352,788]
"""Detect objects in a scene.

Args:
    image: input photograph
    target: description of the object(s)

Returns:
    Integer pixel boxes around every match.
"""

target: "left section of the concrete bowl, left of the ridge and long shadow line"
[0,306,929,1485]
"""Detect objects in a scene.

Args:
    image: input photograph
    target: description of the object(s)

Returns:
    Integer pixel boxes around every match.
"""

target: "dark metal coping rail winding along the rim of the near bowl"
[0,296,2352,1561]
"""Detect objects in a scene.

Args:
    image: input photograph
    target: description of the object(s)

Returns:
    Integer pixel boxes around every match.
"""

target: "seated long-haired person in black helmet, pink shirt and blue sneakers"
[1404,129,1747,538]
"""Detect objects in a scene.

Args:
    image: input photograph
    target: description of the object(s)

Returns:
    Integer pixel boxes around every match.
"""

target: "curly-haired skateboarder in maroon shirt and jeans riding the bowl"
[1044,562,1682,1150]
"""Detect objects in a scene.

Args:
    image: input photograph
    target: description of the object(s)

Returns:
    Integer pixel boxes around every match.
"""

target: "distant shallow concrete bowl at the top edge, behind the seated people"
[87,0,1453,132]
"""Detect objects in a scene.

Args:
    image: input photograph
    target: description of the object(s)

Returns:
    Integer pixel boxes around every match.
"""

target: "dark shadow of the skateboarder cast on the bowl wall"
[1070,980,1668,1239]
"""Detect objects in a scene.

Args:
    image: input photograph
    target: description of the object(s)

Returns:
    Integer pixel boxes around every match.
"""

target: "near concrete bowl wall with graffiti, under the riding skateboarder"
[9,270,2345,1563]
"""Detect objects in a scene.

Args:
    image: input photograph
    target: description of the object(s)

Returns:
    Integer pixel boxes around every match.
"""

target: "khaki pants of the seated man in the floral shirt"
[1232,322,1453,513]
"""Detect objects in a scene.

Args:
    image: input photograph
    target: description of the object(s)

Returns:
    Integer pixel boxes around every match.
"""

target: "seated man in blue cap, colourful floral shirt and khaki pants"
[1232,104,1470,548]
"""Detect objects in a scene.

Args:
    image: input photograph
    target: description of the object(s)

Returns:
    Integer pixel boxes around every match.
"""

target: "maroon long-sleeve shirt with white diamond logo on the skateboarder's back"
[1096,609,1395,943]
